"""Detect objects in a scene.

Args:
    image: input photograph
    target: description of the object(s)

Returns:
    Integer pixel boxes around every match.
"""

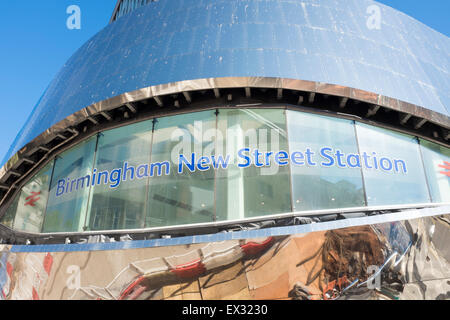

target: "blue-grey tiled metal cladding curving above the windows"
[3,0,450,163]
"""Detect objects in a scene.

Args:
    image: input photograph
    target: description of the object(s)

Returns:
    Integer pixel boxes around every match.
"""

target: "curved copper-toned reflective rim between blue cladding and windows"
[0,77,450,205]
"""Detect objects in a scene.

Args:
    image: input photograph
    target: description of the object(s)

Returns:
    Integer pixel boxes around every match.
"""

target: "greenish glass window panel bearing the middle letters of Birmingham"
[88,121,153,230]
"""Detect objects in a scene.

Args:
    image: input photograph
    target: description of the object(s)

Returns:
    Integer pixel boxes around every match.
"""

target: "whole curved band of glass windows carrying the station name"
[0,108,450,233]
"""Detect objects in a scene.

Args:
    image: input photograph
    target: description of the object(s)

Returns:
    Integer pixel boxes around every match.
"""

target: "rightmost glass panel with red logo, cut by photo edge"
[420,140,450,202]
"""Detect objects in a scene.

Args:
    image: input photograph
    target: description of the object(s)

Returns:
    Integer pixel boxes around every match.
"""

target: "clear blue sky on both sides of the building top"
[0,0,450,162]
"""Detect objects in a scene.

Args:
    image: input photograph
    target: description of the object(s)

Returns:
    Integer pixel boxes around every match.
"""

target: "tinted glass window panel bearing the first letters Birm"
[43,137,97,233]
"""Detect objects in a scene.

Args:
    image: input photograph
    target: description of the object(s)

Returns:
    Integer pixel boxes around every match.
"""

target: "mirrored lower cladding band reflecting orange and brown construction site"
[0,218,450,300]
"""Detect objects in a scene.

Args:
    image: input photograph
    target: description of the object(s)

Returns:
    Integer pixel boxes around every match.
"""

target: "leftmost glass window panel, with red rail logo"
[14,162,53,233]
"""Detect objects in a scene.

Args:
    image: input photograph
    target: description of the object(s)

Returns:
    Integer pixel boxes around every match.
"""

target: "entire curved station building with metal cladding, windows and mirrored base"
[0,0,450,299]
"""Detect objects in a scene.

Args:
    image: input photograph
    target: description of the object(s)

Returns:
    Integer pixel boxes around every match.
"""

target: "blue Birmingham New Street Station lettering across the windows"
[55,146,408,197]
